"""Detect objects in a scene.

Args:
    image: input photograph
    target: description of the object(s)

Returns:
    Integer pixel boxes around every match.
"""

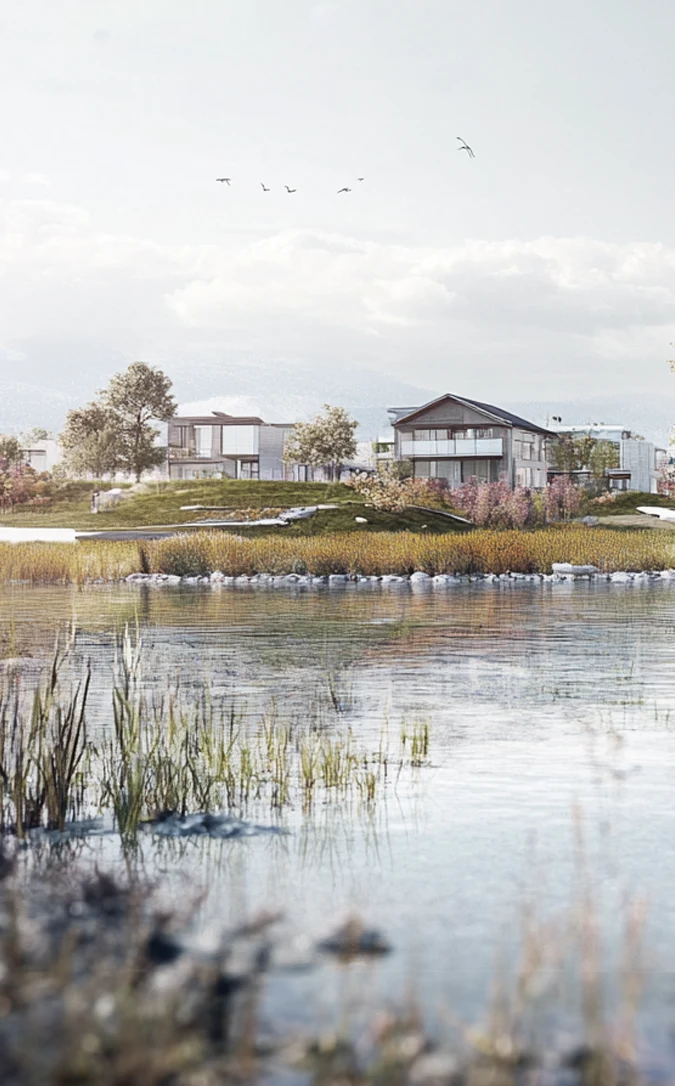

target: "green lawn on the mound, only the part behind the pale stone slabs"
[0,479,360,531]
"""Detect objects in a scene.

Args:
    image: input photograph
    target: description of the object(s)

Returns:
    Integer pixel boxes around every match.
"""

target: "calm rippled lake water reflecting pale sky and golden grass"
[0,584,675,1046]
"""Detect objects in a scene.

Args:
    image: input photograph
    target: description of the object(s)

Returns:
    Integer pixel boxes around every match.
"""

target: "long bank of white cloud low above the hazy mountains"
[0,193,675,401]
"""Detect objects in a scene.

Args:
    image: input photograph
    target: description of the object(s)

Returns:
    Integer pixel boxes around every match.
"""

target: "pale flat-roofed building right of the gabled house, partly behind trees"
[549,422,668,494]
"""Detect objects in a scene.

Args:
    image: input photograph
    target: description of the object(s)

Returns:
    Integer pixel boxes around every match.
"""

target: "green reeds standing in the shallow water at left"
[0,630,429,841]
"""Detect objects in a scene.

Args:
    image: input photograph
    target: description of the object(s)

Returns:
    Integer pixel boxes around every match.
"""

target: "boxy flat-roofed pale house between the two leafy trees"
[167,412,293,479]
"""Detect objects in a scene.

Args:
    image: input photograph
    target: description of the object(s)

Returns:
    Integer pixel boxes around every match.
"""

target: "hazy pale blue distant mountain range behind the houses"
[0,355,675,445]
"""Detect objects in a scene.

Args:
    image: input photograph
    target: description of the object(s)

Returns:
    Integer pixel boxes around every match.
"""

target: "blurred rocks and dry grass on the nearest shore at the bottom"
[0,825,655,1086]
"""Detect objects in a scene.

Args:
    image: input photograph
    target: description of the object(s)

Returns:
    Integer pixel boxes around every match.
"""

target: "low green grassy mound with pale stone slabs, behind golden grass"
[0,479,468,535]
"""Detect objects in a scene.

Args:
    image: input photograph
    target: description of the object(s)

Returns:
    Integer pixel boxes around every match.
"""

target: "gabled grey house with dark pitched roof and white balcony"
[383,393,555,488]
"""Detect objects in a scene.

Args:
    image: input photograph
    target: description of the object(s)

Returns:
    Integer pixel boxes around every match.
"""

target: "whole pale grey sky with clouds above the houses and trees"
[0,0,675,440]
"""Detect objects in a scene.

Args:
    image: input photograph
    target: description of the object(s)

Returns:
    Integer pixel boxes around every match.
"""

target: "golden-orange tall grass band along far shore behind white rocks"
[0,525,675,584]
